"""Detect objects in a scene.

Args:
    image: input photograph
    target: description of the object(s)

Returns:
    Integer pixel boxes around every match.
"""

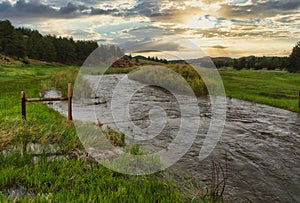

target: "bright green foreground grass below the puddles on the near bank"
[0,151,180,202]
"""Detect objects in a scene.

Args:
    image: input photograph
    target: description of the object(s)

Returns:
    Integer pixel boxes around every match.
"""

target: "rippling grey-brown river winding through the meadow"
[47,75,300,202]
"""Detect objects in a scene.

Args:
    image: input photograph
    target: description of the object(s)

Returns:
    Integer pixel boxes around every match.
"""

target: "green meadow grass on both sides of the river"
[0,65,300,202]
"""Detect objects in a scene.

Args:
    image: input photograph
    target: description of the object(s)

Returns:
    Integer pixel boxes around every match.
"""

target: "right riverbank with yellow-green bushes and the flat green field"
[129,64,300,112]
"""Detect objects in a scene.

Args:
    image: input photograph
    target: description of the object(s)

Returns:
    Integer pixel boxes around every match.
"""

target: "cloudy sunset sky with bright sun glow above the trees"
[0,0,300,58]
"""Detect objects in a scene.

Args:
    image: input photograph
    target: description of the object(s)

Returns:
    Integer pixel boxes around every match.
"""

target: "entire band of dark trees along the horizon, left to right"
[0,20,300,72]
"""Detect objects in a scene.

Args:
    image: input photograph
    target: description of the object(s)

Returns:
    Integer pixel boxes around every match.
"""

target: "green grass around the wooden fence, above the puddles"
[0,66,78,150]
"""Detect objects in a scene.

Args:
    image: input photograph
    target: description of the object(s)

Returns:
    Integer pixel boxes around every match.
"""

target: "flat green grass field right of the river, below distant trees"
[220,70,300,112]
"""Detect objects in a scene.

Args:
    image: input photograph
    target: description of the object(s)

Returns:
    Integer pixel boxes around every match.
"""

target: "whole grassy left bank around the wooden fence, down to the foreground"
[0,66,221,202]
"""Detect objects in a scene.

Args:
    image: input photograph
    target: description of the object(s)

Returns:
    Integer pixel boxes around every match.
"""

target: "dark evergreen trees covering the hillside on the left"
[0,20,123,65]
